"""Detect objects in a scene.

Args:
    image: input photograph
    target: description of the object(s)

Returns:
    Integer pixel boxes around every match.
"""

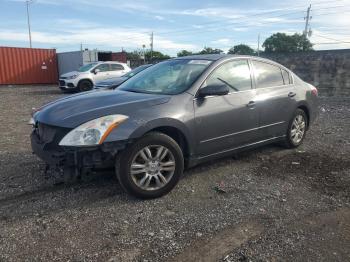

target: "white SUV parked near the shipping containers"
[59,62,131,91]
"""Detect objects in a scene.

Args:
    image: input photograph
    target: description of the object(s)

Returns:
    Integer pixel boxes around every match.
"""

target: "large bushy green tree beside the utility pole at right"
[263,33,313,53]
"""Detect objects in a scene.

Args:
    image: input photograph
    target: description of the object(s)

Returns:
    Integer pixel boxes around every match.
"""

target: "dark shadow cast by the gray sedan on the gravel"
[0,145,281,221]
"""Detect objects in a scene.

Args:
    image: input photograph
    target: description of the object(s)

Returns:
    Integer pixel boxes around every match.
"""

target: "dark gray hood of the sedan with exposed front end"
[34,90,170,128]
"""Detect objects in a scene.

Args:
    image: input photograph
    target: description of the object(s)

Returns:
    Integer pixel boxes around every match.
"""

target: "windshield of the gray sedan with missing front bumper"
[118,59,211,95]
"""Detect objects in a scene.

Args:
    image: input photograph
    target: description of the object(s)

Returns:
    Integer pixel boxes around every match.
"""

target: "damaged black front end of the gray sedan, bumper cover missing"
[31,123,128,176]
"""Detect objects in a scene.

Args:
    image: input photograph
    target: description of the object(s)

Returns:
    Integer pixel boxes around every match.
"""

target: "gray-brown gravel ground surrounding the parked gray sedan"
[0,86,350,261]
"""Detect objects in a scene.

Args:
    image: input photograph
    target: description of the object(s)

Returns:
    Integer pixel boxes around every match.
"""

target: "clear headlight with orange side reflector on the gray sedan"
[59,115,128,146]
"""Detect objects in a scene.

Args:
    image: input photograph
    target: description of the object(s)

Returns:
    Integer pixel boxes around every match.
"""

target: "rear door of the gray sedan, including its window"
[252,60,296,139]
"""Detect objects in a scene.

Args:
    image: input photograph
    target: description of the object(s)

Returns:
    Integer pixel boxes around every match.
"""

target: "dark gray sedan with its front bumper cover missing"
[31,55,318,198]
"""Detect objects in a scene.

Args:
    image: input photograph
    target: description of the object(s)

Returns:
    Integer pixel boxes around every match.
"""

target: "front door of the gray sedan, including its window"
[194,59,259,157]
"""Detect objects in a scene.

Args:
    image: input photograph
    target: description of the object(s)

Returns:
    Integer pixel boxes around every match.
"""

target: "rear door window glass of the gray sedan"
[252,60,284,88]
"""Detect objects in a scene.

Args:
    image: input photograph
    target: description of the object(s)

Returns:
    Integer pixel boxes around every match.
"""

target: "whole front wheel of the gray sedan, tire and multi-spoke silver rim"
[115,132,184,199]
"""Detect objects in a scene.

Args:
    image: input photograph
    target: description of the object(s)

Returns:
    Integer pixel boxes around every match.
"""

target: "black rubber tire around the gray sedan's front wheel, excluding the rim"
[116,133,184,199]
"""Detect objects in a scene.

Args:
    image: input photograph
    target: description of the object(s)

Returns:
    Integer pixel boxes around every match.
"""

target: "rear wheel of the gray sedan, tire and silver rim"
[284,109,308,148]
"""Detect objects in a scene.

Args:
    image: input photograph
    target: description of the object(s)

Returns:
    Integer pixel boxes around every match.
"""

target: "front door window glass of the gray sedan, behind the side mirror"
[206,60,252,92]
